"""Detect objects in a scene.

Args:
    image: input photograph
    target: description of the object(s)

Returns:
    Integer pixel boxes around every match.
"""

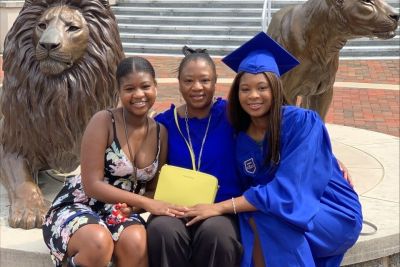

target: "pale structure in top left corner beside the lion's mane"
[0,0,24,54]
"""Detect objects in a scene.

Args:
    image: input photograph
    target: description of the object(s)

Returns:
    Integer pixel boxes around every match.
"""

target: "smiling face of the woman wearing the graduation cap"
[238,73,273,118]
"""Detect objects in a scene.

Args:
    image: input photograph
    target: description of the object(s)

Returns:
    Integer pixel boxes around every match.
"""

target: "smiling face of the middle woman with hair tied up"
[179,58,216,114]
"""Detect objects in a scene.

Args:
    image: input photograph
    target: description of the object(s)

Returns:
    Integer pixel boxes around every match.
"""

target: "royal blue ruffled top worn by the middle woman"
[155,98,242,202]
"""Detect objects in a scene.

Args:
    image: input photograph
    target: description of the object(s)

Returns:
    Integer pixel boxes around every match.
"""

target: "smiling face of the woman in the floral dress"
[119,71,157,116]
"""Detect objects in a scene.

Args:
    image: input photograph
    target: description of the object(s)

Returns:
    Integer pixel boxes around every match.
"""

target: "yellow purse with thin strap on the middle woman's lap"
[154,108,218,206]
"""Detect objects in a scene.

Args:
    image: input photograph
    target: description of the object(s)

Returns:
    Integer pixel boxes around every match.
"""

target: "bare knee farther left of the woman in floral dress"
[67,224,114,267]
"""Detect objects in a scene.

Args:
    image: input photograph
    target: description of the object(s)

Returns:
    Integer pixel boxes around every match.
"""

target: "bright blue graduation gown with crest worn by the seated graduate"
[236,106,362,267]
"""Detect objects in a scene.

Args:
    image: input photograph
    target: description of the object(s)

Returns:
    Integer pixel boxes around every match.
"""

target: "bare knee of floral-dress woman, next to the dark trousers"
[114,224,149,267]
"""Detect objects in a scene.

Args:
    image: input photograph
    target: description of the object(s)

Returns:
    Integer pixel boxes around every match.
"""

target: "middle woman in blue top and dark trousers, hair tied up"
[147,47,242,267]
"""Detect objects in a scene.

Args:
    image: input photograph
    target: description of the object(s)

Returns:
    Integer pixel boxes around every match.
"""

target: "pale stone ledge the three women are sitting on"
[0,125,400,267]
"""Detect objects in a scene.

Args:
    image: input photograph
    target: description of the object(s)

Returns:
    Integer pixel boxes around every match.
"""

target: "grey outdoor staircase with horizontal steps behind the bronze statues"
[113,0,400,58]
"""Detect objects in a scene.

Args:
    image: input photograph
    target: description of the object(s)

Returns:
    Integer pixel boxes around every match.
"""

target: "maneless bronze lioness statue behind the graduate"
[268,0,399,118]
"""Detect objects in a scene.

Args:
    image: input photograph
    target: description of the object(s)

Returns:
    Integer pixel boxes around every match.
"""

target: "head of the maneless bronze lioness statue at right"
[331,0,399,39]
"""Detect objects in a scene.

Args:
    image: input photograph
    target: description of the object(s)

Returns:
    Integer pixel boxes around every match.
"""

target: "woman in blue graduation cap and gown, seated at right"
[181,33,362,267]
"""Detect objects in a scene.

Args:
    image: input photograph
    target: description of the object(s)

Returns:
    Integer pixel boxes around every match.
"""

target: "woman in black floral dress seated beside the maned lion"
[43,57,181,267]
